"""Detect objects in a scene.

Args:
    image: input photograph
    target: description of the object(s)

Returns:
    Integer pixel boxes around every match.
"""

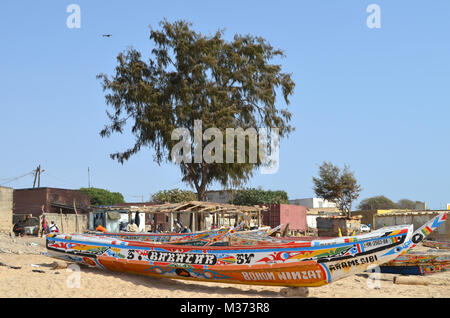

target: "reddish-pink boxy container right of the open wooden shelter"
[262,204,308,232]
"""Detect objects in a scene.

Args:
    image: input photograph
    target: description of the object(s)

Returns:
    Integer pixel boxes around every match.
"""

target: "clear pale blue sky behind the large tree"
[0,0,450,209]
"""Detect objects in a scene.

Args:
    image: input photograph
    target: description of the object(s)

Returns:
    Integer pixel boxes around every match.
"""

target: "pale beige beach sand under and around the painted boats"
[0,234,450,298]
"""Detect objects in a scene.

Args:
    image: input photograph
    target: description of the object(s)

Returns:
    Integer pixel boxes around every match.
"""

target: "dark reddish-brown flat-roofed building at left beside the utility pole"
[13,188,90,217]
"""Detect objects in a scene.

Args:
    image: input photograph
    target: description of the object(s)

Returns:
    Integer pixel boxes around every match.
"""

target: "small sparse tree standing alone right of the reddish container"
[313,162,362,217]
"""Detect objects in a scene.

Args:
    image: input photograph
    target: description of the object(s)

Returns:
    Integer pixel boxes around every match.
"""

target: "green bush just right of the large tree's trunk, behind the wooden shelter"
[230,189,288,205]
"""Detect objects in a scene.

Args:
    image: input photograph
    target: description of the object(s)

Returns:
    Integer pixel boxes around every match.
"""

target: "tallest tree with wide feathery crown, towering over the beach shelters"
[98,20,295,200]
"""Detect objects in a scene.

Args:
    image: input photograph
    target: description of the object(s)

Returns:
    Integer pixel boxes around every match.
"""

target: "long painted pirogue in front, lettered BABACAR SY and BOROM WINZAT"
[46,214,446,286]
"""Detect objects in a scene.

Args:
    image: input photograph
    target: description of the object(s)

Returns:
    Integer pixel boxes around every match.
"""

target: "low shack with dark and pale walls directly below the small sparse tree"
[316,216,361,237]
